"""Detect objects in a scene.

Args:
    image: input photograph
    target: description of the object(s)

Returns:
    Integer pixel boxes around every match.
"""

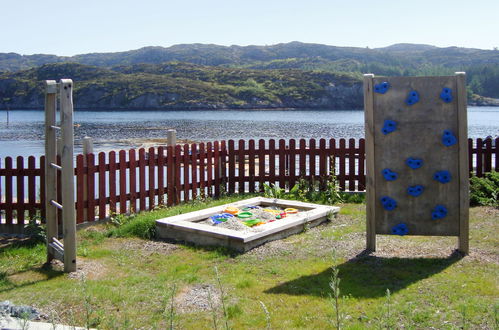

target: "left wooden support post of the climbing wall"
[364,74,376,251]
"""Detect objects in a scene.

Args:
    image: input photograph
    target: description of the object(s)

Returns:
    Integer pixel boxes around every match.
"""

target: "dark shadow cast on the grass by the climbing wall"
[265,252,462,298]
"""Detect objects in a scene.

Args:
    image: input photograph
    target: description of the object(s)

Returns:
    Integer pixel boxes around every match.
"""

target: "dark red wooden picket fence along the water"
[0,139,499,232]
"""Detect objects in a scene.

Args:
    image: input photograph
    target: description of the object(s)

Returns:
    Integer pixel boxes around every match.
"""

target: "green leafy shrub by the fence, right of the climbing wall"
[470,172,499,207]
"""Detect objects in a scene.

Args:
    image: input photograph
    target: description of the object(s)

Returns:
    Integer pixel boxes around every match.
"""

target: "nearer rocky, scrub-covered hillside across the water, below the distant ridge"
[0,62,362,109]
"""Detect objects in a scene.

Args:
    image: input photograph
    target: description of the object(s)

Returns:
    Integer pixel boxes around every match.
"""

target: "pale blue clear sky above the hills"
[0,0,499,56]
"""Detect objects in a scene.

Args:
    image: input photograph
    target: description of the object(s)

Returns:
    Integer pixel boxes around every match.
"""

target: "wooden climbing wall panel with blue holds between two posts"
[364,74,468,250]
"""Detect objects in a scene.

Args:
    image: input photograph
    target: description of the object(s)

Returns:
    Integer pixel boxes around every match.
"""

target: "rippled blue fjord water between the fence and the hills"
[0,107,499,158]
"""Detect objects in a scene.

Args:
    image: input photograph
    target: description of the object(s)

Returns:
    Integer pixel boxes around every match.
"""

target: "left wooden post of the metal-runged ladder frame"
[45,80,58,263]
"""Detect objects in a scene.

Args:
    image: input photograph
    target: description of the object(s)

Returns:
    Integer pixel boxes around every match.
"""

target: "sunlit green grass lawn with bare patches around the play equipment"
[0,196,499,329]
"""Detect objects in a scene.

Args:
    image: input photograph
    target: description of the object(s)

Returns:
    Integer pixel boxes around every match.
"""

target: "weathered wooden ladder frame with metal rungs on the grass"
[45,79,76,272]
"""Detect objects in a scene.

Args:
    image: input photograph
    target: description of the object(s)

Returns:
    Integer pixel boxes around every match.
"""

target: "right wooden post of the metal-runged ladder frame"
[59,79,76,272]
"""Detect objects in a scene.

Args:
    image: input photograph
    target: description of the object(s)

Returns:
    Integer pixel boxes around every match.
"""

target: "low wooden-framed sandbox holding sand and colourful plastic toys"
[156,197,340,252]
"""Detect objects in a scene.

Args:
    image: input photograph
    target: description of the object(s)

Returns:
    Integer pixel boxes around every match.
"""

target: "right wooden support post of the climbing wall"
[456,72,470,254]
